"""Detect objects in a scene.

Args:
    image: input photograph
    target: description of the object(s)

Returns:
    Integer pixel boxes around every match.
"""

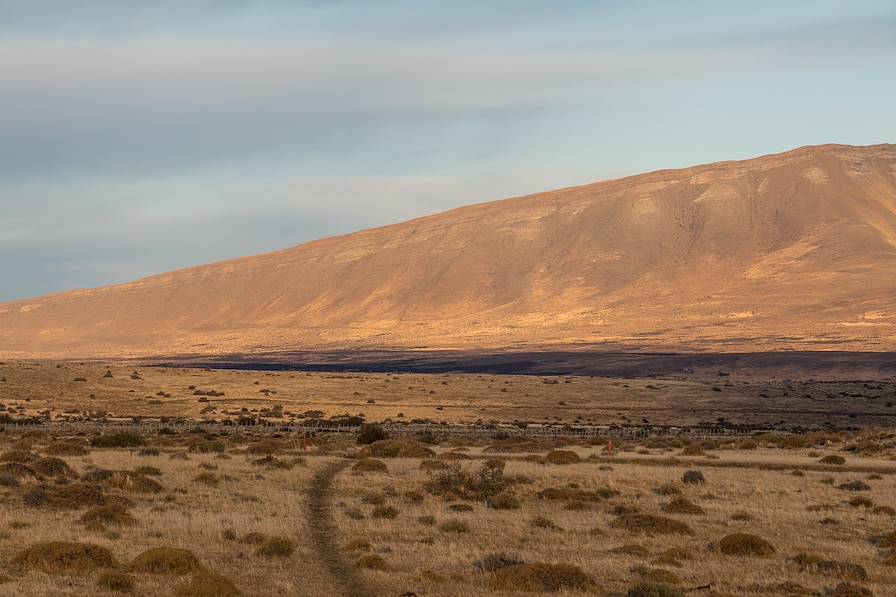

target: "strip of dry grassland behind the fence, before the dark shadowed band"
[0,363,896,427]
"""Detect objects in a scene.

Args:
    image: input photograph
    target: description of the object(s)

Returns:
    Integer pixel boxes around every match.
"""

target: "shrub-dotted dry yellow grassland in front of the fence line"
[0,422,896,597]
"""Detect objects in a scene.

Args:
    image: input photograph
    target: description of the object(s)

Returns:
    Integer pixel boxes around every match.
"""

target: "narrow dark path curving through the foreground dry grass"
[307,460,375,597]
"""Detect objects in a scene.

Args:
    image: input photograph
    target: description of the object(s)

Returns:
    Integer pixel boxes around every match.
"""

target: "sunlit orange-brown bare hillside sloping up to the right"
[0,145,896,358]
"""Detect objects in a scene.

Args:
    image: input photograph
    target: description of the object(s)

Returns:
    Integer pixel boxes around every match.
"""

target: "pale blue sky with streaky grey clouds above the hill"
[0,0,896,302]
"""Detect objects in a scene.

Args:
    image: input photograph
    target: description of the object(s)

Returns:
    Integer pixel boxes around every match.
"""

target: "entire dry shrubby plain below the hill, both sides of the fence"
[0,363,896,597]
